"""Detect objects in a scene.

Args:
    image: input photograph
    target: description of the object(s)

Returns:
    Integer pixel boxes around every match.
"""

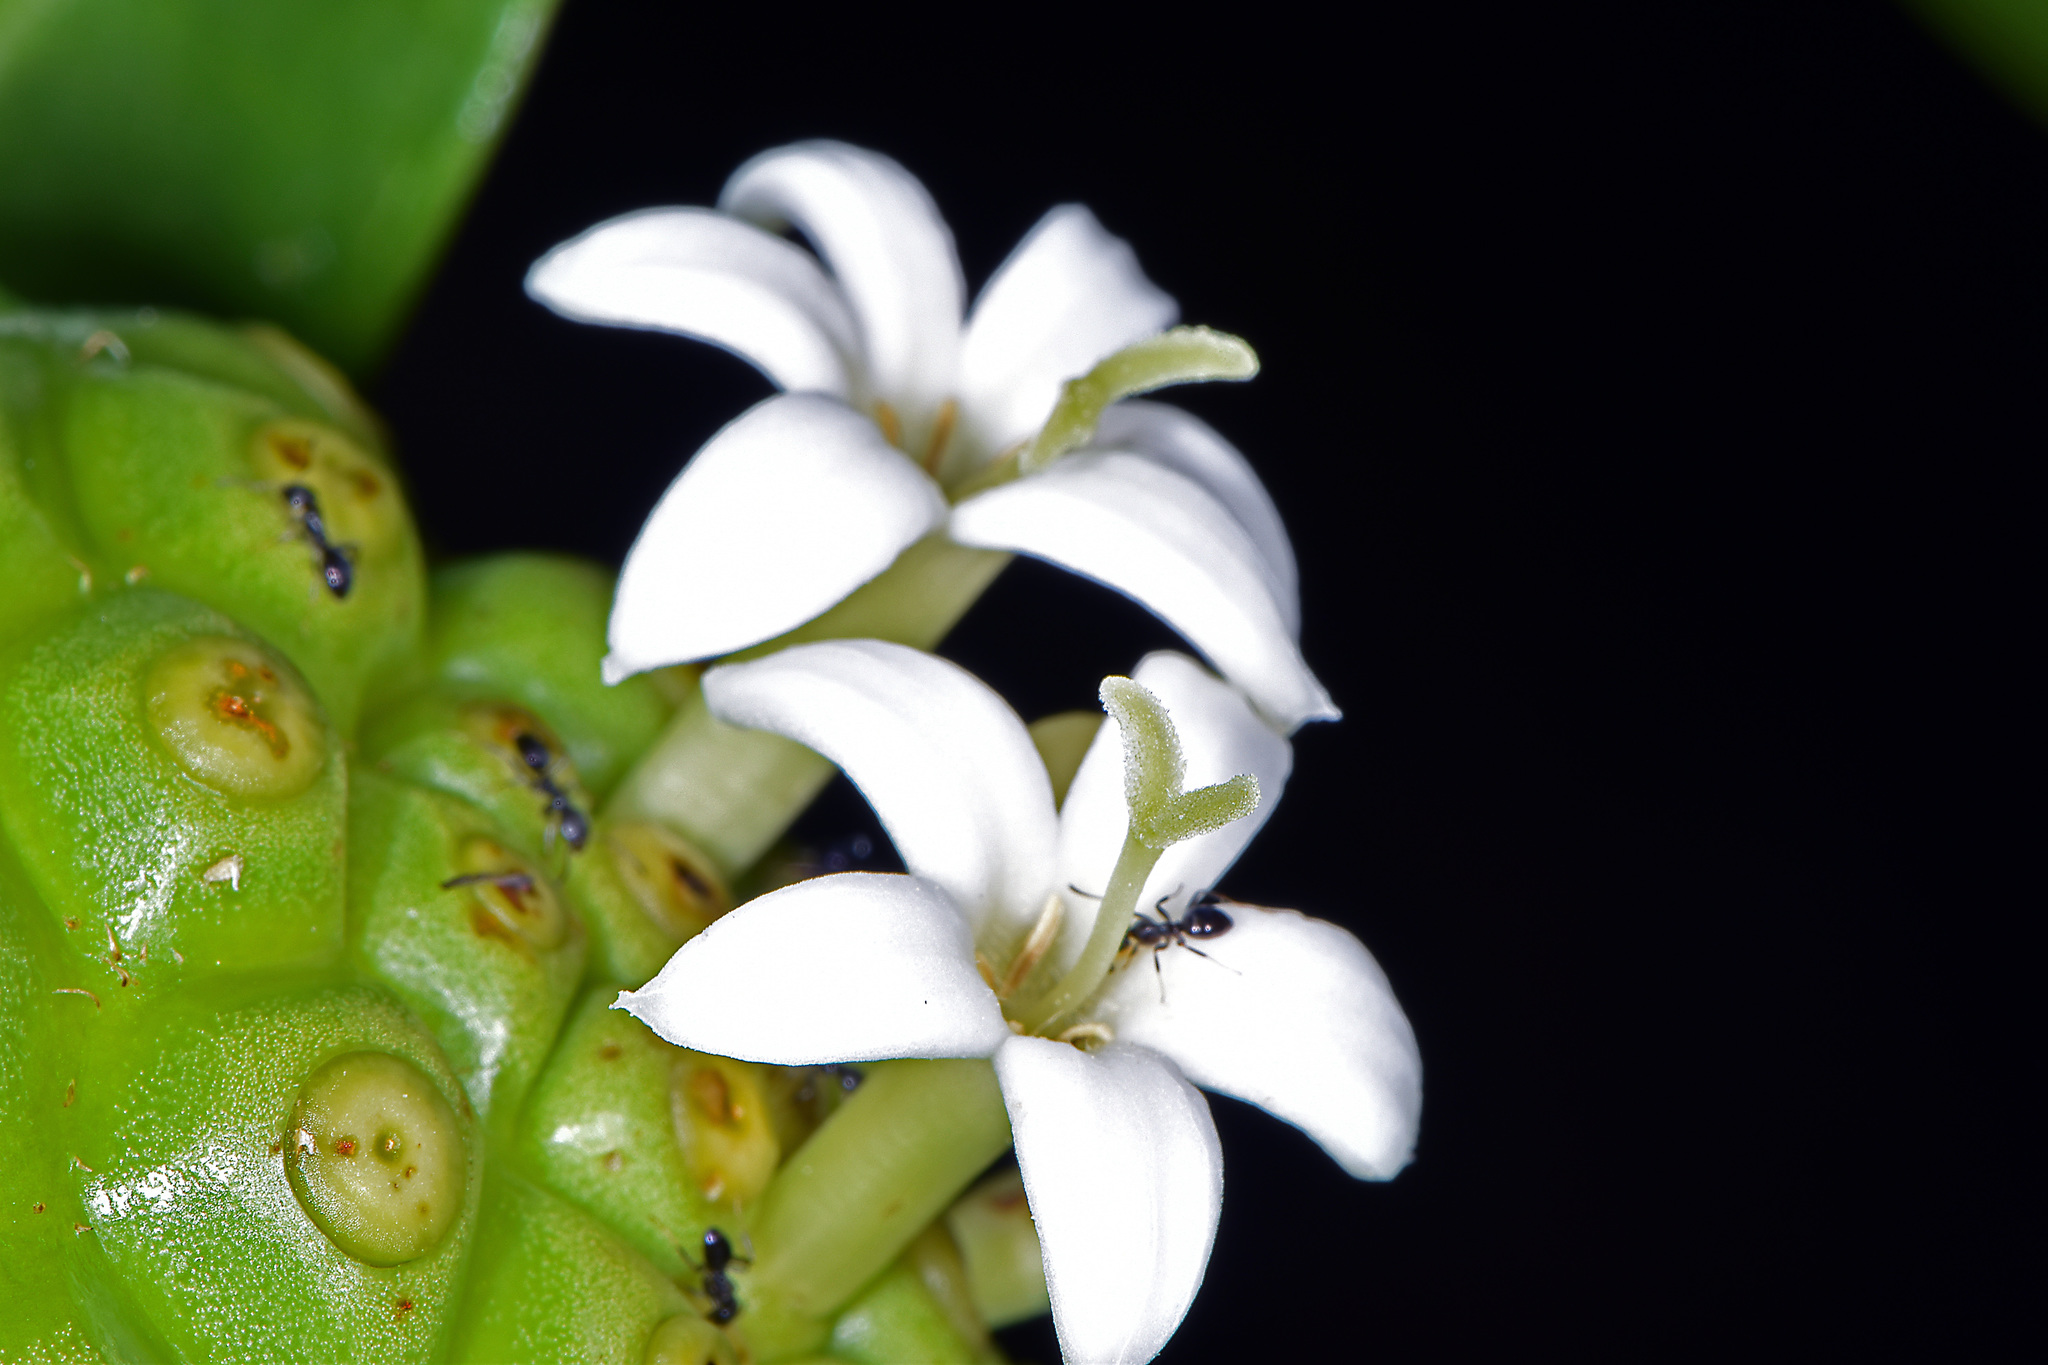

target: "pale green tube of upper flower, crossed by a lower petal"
[606,534,1010,880]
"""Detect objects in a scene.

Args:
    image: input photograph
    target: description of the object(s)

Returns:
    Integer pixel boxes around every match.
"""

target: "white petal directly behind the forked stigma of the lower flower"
[1059,651,1294,960]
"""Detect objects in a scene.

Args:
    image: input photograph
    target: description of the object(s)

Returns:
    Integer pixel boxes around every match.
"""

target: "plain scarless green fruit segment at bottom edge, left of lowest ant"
[451,1173,694,1365]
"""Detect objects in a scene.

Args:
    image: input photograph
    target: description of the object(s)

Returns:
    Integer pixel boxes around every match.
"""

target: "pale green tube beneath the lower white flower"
[748,1058,1010,1326]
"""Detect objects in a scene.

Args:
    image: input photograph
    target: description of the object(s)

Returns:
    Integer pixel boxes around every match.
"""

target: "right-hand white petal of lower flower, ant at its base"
[1092,902,1421,1181]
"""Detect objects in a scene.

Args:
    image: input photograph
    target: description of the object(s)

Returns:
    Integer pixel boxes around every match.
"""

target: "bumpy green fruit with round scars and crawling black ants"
[0,301,1019,1365]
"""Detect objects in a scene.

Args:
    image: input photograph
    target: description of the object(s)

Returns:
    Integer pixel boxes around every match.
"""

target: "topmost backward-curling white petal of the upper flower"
[719,141,967,422]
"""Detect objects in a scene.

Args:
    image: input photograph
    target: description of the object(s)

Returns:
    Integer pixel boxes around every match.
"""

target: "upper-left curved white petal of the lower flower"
[705,641,1057,931]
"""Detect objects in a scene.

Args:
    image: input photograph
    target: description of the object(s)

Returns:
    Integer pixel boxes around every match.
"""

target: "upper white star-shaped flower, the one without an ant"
[526,141,1337,731]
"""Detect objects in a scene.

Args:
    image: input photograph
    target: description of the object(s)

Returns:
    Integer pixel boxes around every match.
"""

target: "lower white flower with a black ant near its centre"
[618,641,1421,1361]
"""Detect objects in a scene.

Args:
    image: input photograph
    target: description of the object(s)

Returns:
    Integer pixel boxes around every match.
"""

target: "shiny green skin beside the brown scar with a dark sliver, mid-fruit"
[348,769,584,1128]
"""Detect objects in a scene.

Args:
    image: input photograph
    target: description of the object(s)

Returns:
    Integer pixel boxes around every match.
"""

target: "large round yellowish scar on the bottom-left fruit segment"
[285,1052,467,1265]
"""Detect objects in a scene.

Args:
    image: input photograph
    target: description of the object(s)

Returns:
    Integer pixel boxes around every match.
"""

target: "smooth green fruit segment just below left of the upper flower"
[426,555,674,798]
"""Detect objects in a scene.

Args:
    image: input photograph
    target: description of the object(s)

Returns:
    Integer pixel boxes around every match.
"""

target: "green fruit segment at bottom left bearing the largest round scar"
[59,978,481,1361]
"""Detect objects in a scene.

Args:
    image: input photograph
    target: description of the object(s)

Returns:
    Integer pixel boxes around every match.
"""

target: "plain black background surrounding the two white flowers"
[373,0,2015,1361]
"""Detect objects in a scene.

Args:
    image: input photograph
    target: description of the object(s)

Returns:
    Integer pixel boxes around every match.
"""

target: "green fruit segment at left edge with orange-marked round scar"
[0,589,346,997]
